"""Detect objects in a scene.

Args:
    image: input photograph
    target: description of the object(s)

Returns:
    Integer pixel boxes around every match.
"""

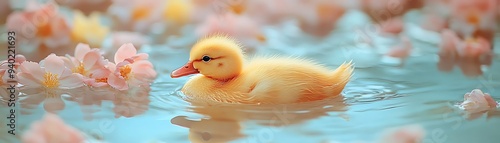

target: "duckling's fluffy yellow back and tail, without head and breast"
[238,57,353,103]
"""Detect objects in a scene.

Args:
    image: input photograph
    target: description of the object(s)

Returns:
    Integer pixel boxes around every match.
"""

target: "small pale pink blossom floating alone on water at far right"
[459,89,498,112]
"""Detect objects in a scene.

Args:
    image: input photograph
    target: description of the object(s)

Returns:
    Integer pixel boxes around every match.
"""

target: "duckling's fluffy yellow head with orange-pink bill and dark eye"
[170,35,244,80]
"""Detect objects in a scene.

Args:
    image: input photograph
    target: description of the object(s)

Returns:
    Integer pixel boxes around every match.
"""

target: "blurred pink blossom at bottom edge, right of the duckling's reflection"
[380,125,425,143]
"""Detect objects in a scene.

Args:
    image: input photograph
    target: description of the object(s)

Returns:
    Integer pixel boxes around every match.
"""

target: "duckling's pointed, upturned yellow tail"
[330,60,354,95]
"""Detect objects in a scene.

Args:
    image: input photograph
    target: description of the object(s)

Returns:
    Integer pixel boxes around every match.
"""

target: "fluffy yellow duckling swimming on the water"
[171,35,353,104]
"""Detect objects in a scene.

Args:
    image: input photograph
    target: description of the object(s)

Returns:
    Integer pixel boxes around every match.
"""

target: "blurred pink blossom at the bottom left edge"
[21,113,85,143]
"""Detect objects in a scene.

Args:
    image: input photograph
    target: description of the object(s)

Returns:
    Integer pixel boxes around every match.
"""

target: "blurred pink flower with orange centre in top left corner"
[7,0,70,48]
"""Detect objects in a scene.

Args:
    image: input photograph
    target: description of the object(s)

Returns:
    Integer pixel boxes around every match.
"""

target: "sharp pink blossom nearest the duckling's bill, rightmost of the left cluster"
[108,43,156,90]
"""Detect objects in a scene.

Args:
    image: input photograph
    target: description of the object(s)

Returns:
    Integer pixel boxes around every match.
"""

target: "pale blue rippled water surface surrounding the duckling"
[0,10,500,143]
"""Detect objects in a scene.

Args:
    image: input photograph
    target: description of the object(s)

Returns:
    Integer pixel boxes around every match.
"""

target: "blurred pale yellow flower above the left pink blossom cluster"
[71,11,109,47]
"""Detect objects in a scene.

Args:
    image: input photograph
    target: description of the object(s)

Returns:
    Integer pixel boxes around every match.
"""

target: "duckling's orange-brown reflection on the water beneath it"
[171,96,347,143]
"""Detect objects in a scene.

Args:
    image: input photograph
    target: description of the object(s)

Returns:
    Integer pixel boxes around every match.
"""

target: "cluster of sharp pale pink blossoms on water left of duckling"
[17,43,156,90]
